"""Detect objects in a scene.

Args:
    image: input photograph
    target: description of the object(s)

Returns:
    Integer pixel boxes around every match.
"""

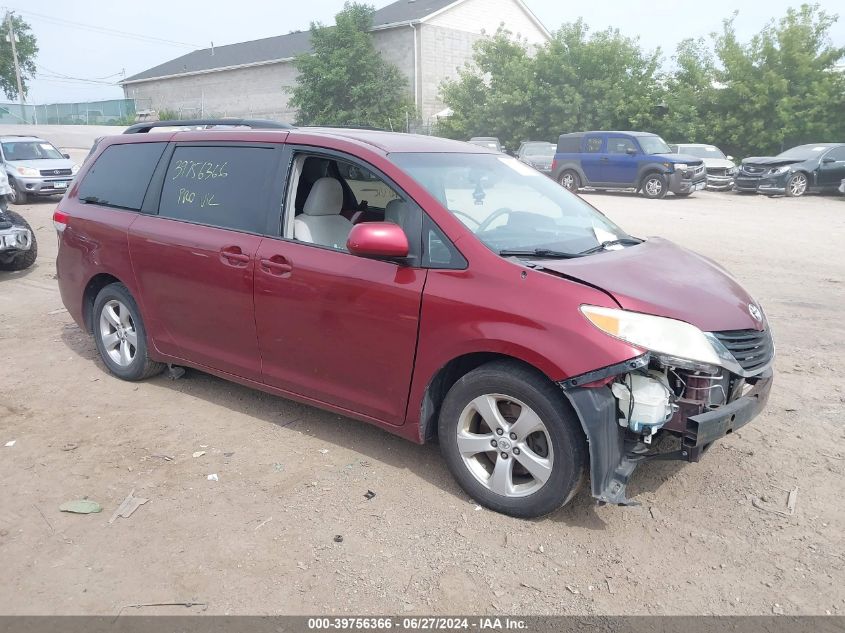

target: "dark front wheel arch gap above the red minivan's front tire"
[419,351,553,443]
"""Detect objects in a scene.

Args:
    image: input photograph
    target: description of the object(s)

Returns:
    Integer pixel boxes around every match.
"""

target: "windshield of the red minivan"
[390,153,629,253]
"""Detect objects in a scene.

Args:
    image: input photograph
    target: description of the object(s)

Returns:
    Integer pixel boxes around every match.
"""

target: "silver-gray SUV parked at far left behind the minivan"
[0,135,79,204]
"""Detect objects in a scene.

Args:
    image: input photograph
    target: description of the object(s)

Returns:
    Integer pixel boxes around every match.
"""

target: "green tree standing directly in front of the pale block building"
[290,2,416,130]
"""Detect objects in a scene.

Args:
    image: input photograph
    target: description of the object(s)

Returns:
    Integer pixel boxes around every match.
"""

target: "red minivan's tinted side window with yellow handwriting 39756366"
[159,146,279,233]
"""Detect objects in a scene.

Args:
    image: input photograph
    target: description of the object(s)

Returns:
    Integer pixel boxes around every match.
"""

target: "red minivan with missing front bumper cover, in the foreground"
[54,120,774,517]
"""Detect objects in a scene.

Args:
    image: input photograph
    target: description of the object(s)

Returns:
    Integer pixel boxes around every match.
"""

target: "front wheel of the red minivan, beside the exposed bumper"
[438,361,587,518]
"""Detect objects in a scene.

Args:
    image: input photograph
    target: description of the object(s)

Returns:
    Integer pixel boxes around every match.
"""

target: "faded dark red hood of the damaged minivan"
[538,237,763,332]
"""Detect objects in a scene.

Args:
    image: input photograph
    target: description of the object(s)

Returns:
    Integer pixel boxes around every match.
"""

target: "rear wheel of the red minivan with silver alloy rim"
[91,283,164,381]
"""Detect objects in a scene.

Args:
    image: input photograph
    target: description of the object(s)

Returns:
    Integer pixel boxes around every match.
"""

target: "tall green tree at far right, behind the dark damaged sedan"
[712,4,845,156]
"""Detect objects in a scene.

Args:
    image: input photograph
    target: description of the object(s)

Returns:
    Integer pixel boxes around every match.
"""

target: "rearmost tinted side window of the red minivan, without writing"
[77,143,167,211]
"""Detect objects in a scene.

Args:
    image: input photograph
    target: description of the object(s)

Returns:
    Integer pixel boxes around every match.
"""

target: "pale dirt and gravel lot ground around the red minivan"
[0,154,845,614]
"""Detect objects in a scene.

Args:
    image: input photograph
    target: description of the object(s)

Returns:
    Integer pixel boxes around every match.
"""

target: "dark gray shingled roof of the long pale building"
[120,0,460,84]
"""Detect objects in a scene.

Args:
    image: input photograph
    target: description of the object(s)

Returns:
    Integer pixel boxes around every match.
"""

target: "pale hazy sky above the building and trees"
[6,0,845,104]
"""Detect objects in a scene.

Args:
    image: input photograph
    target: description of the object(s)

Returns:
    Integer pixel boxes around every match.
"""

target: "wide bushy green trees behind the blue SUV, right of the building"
[440,20,661,147]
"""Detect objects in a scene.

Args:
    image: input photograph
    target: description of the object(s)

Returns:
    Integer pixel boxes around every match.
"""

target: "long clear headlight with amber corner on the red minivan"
[581,305,722,367]
